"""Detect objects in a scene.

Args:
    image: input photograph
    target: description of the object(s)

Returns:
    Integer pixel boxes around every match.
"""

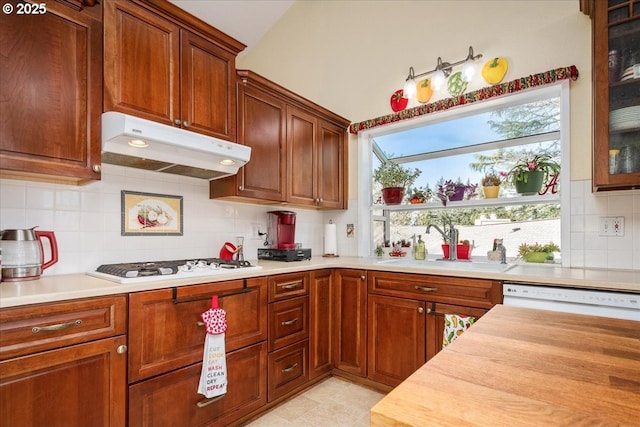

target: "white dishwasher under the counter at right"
[502,283,640,321]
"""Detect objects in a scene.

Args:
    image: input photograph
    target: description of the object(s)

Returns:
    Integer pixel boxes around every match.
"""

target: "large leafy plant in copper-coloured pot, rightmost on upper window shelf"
[507,154,560,195]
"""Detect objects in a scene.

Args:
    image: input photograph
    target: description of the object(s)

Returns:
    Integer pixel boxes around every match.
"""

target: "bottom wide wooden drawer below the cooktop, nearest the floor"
[129,343,267,427]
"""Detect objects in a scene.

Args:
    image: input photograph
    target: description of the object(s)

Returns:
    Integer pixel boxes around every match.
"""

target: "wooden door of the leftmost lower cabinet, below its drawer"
[0,336,127,427]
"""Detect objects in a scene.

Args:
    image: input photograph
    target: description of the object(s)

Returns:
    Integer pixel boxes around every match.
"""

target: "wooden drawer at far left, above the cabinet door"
[0,295,127,360]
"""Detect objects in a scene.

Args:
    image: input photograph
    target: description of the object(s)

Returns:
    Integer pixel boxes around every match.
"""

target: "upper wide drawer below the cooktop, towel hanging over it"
[129,277,267,382]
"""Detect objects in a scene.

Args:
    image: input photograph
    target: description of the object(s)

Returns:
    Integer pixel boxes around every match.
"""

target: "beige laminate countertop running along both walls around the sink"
[0,257,640,308]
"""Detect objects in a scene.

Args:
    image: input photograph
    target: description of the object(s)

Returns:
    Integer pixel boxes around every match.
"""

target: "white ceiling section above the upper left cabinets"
[170,0,295,52]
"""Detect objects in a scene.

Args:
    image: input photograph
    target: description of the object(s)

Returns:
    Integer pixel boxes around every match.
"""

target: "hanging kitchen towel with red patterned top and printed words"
[198,295,227,397]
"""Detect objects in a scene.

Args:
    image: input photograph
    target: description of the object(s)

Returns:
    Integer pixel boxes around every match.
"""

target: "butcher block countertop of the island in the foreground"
[371,305,640,427]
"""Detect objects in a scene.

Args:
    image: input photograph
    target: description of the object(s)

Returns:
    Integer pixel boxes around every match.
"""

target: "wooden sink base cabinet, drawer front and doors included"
[367,271,502,387]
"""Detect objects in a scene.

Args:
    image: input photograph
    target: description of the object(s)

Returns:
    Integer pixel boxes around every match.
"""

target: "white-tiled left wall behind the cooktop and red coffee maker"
[0,164,323,275]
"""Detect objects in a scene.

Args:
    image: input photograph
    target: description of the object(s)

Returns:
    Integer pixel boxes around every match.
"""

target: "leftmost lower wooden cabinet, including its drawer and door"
[0,295,127,427]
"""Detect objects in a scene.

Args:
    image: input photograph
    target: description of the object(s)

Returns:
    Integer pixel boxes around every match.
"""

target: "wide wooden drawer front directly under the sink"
[368,271,502,308]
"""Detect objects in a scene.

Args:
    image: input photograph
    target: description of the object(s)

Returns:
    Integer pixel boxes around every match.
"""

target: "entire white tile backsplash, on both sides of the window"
[0,171,640,275]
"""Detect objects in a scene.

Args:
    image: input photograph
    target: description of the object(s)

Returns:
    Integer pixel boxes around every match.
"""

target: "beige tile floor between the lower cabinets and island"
[246,377,384,427]
